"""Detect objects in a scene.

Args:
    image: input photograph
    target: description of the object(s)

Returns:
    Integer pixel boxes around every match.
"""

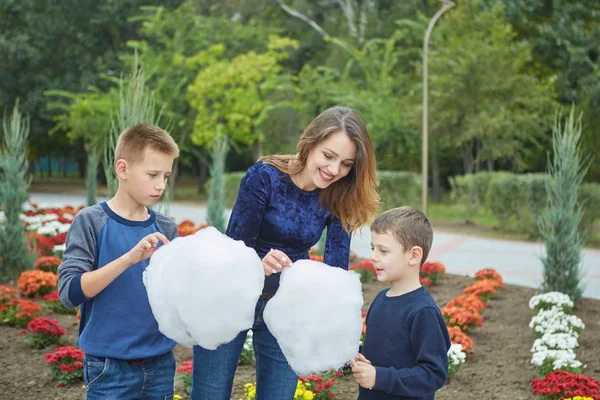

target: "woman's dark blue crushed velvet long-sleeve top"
[226,161,350,293]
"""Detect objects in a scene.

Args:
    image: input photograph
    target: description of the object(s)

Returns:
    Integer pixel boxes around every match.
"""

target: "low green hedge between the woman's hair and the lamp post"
[377,171,421,210]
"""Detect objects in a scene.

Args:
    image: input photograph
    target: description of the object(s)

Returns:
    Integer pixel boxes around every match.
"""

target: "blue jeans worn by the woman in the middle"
[191,298,298,400]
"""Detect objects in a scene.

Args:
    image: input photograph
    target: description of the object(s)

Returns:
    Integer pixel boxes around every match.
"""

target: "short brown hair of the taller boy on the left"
[115,124,179,163]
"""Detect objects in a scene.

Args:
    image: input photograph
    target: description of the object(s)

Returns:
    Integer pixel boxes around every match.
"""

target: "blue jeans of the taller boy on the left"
[83,351,175,400]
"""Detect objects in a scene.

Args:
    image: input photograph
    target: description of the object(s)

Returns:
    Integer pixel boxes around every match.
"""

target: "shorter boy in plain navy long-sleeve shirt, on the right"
[352,207,450,400]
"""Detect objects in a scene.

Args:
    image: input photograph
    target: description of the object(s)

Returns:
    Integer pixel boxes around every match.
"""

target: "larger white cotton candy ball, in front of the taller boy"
[145,227,264,350]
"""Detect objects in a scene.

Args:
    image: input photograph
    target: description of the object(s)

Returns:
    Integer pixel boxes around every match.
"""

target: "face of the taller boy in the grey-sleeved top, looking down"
[125,146,173,207]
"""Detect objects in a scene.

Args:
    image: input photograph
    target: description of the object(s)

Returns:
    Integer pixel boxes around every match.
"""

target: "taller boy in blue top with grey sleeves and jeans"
[58,125,179,400]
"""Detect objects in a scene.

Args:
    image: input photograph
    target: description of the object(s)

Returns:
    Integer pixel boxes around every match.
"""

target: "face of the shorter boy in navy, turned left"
[371,232,414,282]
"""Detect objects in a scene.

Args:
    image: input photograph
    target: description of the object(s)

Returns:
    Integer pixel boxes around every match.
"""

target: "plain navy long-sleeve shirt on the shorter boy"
[358,287,451,400]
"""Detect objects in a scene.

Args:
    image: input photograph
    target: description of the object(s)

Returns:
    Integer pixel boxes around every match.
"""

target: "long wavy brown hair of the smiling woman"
[261,106,379,232]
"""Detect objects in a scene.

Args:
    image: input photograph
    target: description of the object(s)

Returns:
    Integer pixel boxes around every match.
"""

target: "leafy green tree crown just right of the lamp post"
[430,2,553,173]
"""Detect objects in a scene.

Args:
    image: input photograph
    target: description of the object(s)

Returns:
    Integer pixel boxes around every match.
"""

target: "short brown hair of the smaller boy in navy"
[371,206,433,265]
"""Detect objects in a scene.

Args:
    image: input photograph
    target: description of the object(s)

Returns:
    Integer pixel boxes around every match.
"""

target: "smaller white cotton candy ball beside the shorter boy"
[264,260,363,375]
